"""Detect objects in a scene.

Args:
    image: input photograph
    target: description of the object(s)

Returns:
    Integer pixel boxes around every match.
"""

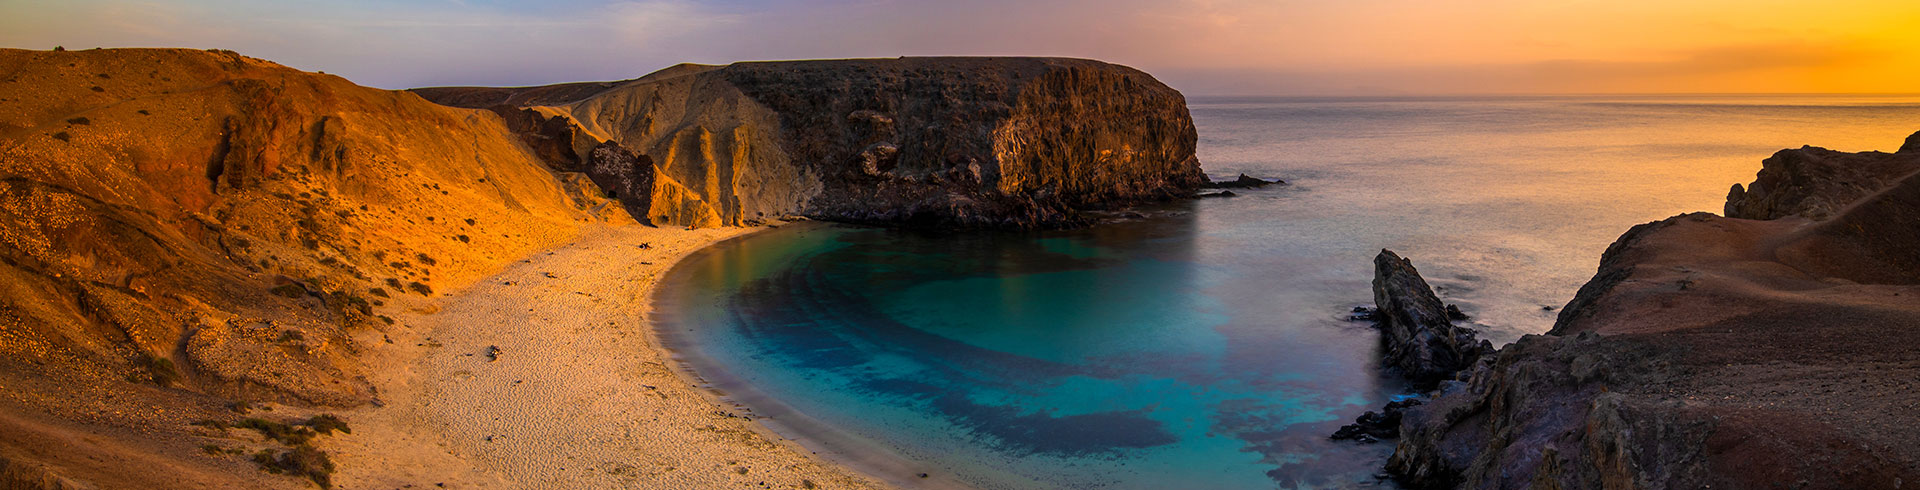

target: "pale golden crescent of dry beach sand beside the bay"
[321,227,883,488]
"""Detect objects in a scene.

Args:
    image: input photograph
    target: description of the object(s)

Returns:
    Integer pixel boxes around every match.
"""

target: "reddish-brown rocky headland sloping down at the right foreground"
[1388,133,1920,488]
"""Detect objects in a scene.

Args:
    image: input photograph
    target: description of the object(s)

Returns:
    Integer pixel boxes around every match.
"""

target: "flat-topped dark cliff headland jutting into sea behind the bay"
[415,58,1206,227]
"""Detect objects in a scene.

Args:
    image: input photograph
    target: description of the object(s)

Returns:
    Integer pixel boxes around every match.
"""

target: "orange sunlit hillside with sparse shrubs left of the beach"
[0,50,624,488]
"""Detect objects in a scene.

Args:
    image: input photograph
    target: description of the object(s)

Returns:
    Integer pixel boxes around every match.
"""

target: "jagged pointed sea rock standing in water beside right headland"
[1373,250,1494,386]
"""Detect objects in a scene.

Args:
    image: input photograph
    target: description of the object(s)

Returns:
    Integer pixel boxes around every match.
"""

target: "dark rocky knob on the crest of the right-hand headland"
[1726,133,1920,219]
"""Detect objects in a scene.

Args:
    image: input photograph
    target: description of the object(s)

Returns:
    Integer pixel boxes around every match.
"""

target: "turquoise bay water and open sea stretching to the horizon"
[659,96,1920,488]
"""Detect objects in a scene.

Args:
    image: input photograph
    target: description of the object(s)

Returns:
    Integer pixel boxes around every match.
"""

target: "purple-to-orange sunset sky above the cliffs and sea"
[0,0,1920,96]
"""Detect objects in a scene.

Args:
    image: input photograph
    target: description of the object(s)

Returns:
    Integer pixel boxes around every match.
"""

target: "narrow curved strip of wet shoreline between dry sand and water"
[649,223,973,490]
